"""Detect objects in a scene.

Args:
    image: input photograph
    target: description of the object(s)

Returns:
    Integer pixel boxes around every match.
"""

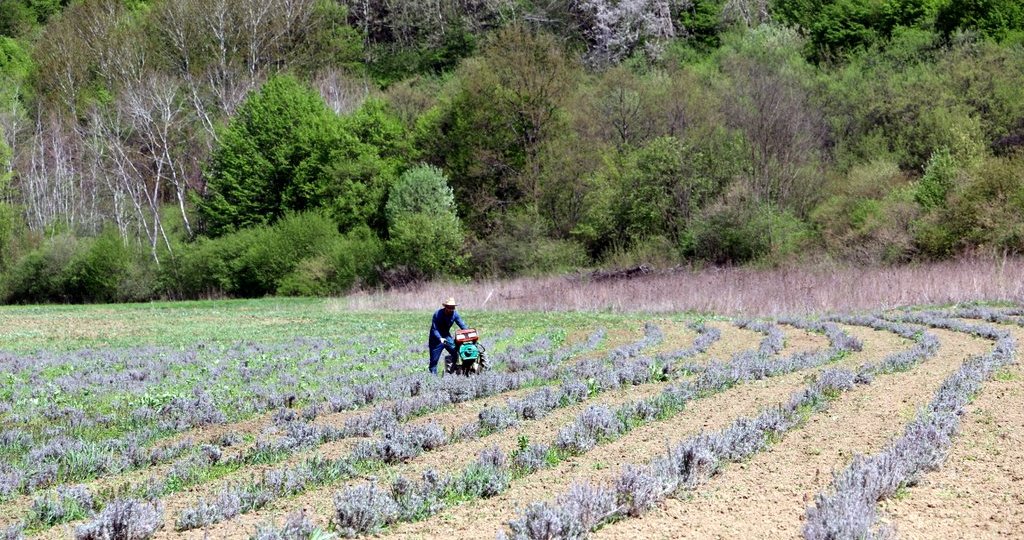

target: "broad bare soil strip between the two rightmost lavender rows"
[592,330,992,539]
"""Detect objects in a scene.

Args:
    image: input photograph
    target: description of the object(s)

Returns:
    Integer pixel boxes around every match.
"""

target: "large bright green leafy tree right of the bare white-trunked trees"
[197,76,409,236]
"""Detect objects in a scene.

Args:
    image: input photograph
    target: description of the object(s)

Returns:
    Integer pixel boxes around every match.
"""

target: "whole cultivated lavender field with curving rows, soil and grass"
[0,299,1024,539]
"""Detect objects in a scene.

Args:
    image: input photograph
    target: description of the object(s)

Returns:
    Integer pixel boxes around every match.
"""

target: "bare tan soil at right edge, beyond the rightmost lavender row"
[882,321,1024,539]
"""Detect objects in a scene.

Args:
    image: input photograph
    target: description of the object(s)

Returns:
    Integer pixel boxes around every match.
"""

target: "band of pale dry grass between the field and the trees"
[335,258,1024,316]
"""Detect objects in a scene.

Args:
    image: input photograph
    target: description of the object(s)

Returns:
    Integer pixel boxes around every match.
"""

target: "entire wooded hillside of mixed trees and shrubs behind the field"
[0,0,1024,302]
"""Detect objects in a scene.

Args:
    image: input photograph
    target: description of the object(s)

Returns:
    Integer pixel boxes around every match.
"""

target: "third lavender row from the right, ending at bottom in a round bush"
[284,319,855,536]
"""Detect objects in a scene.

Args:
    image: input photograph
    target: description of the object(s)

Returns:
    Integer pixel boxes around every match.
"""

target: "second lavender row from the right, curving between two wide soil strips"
[500,320,934,540]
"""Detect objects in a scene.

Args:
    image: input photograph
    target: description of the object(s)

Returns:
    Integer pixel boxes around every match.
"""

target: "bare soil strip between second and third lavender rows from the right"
[372,328,851,539]
